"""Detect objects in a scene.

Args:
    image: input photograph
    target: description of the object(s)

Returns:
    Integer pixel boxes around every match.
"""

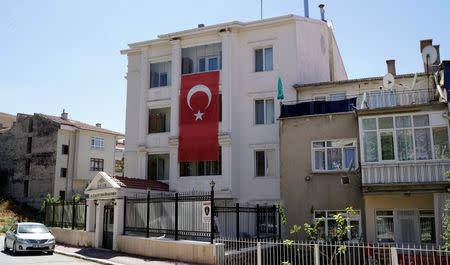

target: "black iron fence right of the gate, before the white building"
[123,193,281,240]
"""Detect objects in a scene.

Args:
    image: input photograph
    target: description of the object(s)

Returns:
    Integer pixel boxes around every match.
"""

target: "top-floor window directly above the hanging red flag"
[181,43,222,74]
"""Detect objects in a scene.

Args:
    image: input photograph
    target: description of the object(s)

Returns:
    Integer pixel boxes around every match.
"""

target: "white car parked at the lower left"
[3,223,55,255]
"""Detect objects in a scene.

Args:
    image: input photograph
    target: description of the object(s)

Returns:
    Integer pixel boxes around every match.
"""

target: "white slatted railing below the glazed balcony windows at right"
[361,161,450,185]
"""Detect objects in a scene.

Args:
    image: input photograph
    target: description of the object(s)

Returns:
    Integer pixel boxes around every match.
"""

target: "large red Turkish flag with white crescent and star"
[178,71,219,162]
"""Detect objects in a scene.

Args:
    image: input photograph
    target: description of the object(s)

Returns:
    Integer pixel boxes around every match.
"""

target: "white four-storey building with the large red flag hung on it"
[121,15,347,204]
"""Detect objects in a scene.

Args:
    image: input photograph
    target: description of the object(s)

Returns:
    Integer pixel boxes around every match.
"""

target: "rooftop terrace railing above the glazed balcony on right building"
[356,89,434,109]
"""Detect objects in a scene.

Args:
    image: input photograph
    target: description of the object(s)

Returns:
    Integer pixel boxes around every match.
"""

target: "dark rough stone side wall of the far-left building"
[0,114,59,208]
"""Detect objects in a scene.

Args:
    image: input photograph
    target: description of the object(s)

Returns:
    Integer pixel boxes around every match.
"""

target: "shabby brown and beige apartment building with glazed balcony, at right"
[280,40,450,244]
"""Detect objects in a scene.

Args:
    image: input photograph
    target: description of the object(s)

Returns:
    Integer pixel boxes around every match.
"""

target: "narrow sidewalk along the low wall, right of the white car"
[55,244,193,265]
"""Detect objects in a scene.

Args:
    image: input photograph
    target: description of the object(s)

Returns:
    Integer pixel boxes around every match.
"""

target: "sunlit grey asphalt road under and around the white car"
[0,236,98,265]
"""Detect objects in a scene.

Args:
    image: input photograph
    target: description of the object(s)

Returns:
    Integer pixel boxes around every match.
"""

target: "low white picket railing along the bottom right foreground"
[216,239,450,265]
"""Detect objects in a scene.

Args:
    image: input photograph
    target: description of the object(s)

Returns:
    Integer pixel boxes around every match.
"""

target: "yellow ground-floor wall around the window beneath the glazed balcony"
[364,193,434,242]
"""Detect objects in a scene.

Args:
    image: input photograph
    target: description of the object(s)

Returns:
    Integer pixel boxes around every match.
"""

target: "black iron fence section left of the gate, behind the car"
[44,200,87,230]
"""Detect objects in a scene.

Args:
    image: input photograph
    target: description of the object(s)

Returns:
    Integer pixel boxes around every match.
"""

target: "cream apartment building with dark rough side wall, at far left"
[0,112,123,207]
